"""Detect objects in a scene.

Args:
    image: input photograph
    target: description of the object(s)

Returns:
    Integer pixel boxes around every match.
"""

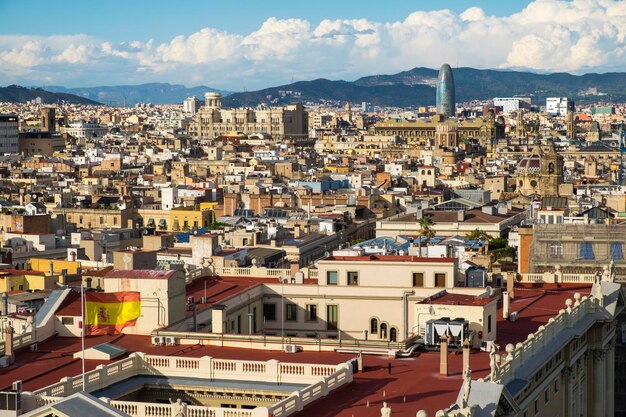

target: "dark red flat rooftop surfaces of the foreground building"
[0,278,591,417]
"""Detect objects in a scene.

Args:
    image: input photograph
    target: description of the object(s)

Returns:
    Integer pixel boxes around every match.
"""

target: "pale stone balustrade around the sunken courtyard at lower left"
[23,353,352,417]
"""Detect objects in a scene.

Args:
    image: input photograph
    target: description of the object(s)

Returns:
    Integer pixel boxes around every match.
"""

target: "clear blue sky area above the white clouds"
[0,0,529,42]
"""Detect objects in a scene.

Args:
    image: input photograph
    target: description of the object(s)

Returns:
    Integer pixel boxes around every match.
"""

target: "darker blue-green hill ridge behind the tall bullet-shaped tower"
[223,68,626,107]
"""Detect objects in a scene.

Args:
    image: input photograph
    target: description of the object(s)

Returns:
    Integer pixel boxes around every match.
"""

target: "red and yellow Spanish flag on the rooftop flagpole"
[85,291,141,335]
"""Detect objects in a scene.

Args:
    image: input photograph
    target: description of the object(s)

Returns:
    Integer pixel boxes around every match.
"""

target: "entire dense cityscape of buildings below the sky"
[0,2,626,417]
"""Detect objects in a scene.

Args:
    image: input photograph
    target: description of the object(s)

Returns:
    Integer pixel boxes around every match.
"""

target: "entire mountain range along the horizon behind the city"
[0,67,626,107]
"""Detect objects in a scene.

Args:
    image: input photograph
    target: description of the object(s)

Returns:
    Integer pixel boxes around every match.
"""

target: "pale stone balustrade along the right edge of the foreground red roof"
[484,294,599,384]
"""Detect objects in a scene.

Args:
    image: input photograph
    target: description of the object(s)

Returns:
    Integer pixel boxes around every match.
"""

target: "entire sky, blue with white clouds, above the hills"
[0,0,626,91]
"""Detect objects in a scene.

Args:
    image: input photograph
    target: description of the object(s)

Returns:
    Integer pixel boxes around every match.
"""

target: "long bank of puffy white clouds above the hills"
[0,0,626,89]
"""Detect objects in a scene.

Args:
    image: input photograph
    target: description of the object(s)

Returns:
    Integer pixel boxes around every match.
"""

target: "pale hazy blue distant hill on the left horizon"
[46,83,229,106]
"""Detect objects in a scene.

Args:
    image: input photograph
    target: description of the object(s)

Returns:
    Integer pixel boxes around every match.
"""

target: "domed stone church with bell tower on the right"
[516,145,563,197]
